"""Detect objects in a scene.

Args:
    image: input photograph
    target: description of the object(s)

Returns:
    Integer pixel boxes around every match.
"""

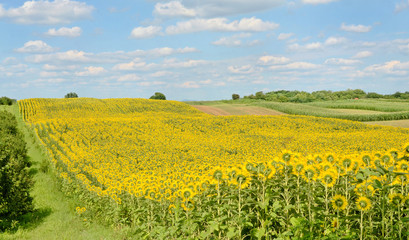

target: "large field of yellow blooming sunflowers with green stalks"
[19,98,409,239]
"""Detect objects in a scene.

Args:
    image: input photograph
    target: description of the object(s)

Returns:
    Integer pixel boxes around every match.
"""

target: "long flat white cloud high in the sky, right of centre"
[166,17,279,34]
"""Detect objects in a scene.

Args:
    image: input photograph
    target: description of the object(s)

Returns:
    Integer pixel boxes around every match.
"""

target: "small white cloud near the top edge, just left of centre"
[153,1,196,17]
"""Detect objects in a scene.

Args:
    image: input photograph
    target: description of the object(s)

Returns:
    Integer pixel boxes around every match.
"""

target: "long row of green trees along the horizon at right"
[244,89,409,103]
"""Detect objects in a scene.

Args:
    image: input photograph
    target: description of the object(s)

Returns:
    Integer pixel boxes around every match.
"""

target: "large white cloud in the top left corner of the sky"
[0,0,94,25]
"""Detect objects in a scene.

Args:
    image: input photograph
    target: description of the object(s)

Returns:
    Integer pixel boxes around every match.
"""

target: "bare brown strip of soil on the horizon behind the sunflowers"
[192,104,284,116]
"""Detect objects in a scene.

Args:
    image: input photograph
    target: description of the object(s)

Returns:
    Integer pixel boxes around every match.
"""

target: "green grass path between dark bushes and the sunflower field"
[0,105,121,240]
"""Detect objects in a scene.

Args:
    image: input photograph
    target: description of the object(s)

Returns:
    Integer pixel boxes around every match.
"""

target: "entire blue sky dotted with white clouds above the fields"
[0,0,409,100]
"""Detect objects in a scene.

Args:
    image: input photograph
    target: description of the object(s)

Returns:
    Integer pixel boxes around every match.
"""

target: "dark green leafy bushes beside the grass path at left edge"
[0,111,33,231]
